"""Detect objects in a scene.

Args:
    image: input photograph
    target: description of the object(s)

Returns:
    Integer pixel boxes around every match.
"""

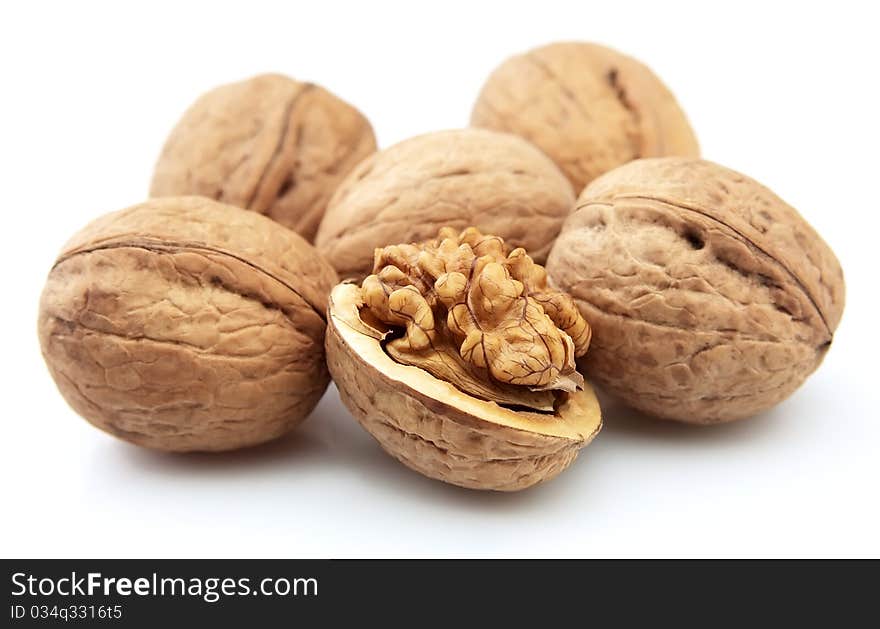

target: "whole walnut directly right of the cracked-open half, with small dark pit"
[547,158,844,423]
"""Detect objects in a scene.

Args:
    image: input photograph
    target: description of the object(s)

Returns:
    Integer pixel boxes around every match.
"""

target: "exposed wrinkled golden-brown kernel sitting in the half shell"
[362,227,590,410]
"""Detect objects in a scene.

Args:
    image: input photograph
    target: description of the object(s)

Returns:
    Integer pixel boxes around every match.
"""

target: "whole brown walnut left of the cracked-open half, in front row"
[39,197,336,451]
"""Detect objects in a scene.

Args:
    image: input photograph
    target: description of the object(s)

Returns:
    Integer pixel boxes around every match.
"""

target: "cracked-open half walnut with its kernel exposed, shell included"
[327,228,601,490]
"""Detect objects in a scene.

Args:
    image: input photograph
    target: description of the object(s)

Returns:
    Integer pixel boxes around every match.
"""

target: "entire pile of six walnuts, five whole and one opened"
[39,43,844,491]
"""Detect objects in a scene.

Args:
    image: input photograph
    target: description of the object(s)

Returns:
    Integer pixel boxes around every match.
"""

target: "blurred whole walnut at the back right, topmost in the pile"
[471,42,699,192]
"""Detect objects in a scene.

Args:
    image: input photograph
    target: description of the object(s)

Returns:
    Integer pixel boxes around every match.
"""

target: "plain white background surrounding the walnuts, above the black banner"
[0,0,880,557]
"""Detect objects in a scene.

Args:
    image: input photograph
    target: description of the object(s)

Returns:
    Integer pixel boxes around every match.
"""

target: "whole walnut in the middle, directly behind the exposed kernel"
[315,129,574,279]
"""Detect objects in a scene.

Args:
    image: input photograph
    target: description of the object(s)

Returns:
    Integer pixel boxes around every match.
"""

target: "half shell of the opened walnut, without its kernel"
[326,284,602,491]
